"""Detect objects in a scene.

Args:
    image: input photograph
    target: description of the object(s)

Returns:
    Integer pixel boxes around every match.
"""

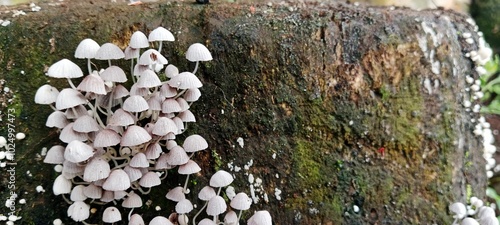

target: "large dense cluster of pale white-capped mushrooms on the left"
[35,27,271,224]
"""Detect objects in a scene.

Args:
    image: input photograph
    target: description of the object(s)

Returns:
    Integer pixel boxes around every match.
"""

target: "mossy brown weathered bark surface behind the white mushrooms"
[0,2,487,224]
